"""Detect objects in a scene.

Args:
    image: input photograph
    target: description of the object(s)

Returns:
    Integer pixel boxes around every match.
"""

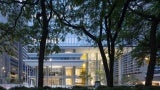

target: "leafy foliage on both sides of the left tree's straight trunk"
[0,0,65,54]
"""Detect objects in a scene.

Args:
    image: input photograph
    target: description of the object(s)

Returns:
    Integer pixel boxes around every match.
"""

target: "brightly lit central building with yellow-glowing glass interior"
[24,46,105,86]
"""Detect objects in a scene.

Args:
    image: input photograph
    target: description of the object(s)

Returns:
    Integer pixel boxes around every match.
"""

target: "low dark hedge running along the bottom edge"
[5,85,160,90]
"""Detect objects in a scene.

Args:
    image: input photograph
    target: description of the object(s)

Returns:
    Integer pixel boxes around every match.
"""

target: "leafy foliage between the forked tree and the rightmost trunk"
[120,0,160,66]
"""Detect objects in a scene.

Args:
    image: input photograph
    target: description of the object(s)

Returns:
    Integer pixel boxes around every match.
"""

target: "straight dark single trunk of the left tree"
[38,0,48,88]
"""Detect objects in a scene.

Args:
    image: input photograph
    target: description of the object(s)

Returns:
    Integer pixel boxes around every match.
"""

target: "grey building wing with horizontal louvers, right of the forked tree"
[114,47,160,86]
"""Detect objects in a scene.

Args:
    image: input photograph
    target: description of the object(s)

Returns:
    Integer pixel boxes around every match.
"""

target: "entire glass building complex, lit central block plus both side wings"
[0,36,160,87]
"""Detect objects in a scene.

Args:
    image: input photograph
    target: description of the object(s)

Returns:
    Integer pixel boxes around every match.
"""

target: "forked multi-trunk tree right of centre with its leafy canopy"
[53,0,131,87]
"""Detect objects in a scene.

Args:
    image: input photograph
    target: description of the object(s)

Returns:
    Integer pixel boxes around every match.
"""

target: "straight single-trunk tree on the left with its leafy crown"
[0,0,58,88]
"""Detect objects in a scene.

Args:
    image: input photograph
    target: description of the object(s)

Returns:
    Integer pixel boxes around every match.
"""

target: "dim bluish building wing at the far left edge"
[0,43,27,84]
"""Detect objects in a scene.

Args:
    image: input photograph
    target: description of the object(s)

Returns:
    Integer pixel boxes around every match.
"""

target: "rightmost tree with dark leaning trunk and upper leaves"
[126,0,160,86]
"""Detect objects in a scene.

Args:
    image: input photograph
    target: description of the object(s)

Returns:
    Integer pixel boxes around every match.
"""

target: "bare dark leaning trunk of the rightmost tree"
[145,20,158,86]
